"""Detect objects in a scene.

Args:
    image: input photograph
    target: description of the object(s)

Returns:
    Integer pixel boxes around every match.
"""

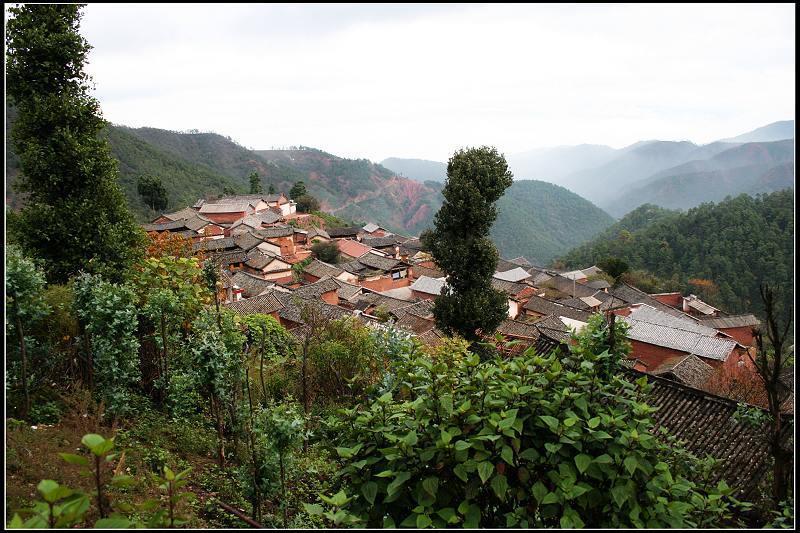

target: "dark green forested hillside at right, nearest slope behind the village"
[563,190,794,313]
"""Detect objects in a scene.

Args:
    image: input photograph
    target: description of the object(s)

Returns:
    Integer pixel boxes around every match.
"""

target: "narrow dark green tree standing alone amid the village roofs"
[424,146,512,341]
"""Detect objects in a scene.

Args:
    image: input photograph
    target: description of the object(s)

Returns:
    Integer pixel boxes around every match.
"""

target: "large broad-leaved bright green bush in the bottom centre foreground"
[316,330,748,528]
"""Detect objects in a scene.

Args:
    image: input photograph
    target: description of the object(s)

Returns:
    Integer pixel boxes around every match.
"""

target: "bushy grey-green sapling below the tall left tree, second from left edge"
[74,274,141,417]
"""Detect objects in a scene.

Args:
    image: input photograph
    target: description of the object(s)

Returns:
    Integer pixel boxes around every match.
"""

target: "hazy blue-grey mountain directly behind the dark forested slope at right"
[606,140,794,216]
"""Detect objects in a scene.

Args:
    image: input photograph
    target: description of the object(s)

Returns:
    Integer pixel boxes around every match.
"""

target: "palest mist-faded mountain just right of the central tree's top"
[507,144,618,183]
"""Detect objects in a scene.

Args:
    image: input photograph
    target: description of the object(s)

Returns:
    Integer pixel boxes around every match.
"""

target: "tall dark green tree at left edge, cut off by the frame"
[6,4,144,283]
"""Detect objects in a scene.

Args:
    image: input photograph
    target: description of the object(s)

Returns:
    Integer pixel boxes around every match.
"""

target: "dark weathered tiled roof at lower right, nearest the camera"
[623,369,793,499]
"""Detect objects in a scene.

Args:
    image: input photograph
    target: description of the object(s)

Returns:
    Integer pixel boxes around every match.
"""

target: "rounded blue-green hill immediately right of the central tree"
[491,180,614,266]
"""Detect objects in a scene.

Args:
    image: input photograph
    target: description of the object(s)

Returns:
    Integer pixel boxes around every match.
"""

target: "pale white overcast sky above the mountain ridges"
[73,4,795,161]
